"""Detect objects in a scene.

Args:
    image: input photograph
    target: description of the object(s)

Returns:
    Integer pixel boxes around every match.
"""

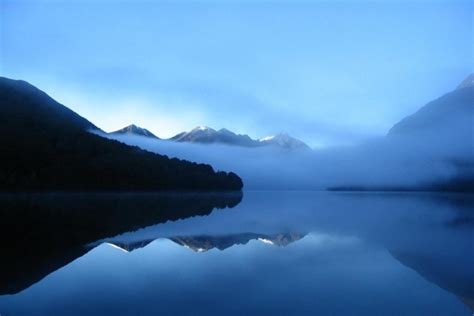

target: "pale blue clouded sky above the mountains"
[0,0,474,147]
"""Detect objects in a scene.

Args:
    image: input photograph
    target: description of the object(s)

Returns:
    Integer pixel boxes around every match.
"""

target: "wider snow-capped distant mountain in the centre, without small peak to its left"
[170,126,309,149]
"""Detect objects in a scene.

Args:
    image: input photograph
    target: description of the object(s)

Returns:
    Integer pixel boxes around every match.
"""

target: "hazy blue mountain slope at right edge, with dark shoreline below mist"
[334,74,474,192]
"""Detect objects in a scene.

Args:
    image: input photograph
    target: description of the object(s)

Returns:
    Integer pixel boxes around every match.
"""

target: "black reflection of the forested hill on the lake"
[0,192,242,294]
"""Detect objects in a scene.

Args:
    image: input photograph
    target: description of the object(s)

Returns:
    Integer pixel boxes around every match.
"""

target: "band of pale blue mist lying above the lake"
[93,128,474,190]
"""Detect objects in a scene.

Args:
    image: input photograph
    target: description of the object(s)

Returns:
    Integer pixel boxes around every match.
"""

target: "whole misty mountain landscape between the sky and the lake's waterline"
[0,74,474,192]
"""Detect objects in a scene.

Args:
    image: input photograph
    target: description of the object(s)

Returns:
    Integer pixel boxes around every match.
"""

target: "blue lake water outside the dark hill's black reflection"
[0,192,474,315]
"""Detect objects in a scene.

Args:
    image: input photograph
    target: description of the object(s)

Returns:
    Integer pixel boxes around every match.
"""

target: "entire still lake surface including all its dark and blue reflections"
[0,192,474,316]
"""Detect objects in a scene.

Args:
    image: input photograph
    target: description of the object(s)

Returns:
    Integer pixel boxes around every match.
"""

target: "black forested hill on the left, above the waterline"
[0,77,243,191]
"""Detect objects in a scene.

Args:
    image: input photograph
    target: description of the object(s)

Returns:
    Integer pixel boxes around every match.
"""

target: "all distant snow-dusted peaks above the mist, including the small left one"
[110,125,310,150]
